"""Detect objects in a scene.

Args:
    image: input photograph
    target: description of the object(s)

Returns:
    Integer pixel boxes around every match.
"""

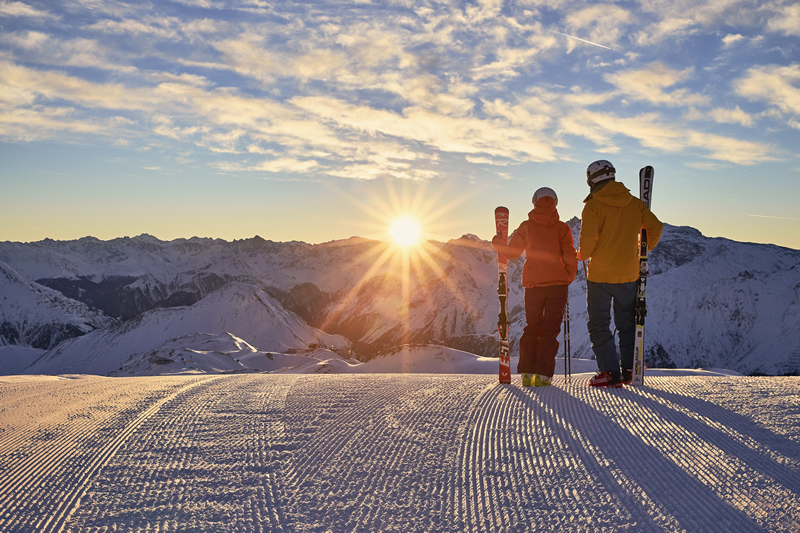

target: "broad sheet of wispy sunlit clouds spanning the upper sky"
[0,0,800,179]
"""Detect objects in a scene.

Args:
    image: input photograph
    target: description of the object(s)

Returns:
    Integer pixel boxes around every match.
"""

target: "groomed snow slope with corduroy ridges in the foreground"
[0,374,800,532]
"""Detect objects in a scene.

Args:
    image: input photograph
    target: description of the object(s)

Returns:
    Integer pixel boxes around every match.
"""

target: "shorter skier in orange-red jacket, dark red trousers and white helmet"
[492,187,578,387]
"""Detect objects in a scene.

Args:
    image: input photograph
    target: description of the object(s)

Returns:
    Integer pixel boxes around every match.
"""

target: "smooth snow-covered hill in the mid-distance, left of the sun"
[26,282,350,375]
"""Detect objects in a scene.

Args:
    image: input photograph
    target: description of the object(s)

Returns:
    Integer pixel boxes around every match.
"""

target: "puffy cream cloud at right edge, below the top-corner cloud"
[733,65,800,115]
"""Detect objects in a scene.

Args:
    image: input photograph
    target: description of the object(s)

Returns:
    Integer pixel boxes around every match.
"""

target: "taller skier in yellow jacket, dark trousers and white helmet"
[578,160,664,388]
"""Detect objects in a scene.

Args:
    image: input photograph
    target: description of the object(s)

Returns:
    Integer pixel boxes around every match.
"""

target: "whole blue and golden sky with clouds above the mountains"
[0,0,800,249]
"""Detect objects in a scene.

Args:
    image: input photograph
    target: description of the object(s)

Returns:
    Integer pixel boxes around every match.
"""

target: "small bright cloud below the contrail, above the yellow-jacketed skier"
[604,62,709,106]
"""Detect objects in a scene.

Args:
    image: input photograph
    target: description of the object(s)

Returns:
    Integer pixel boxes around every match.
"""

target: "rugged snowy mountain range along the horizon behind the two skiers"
[0,219,800,374]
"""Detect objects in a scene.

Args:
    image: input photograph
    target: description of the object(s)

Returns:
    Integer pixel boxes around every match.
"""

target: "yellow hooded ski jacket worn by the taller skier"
[578,181,664,283]
